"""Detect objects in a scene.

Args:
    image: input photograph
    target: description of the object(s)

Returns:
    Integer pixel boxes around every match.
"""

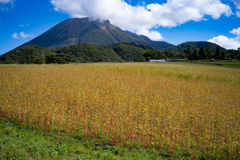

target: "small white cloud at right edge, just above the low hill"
[208,35,240,49]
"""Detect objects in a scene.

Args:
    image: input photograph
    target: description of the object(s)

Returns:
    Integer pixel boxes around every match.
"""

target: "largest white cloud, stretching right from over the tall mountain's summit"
[51,0,232,40]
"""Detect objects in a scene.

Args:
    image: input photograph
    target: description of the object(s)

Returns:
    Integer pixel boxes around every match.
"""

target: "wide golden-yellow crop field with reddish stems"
[0,63,240,159]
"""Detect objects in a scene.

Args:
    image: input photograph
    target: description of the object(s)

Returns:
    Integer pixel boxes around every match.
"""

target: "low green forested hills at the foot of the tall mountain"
[0,42,153,64]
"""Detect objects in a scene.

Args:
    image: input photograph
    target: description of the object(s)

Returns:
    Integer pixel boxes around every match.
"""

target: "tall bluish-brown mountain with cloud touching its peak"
[22,18,174,50]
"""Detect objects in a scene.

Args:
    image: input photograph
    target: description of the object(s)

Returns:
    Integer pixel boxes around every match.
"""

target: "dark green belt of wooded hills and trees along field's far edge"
[0,42,240,64]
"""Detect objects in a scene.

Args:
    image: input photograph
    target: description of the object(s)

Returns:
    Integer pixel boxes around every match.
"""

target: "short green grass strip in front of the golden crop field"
[0,122,167,160]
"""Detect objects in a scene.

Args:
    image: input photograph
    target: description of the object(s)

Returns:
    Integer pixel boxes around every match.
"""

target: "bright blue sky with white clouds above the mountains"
[0,0,240,55]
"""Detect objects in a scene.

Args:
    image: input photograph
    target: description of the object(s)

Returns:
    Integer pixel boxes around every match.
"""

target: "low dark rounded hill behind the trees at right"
[164,41,226,53]
